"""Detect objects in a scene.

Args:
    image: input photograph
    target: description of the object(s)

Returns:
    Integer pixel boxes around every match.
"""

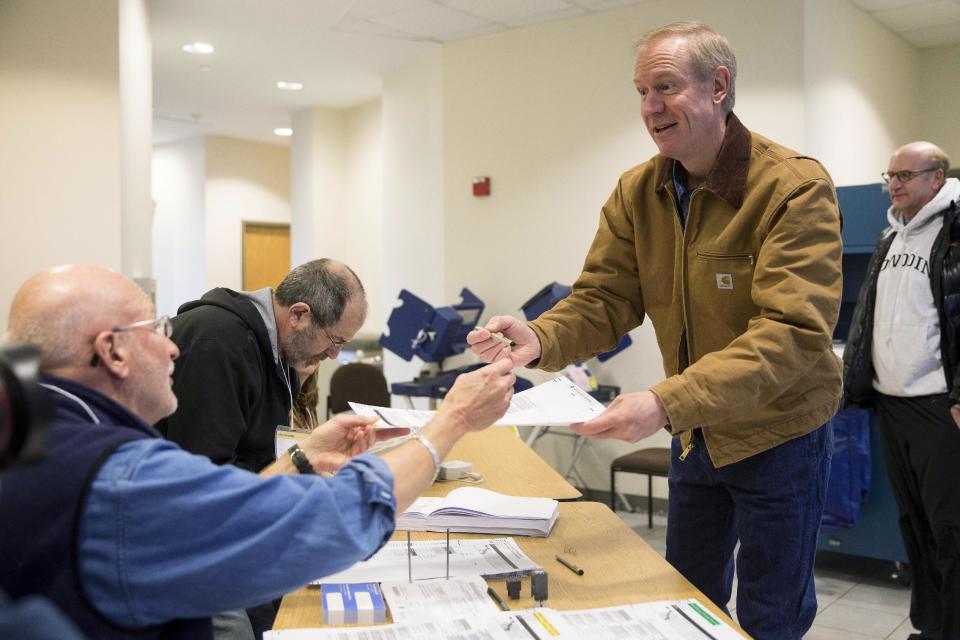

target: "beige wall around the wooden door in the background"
[204,136,290,289]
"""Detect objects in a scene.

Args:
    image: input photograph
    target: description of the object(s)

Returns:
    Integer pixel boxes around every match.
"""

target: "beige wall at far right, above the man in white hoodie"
[917,45,960,162]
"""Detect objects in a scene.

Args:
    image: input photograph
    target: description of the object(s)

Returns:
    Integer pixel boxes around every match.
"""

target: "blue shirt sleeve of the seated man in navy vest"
[78,439,396,626]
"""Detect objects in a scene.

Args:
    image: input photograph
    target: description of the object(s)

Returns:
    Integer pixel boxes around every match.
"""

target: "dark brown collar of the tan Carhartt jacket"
[656,112,752,209]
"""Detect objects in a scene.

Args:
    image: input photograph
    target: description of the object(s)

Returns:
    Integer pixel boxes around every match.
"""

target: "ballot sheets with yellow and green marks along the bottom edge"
[264,600,743,640]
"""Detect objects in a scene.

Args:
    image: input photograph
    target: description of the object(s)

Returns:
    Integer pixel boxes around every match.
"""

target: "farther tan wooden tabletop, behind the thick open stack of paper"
[423,427,582,500]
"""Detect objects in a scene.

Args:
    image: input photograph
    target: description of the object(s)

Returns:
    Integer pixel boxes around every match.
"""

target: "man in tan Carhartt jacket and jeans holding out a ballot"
[468,23,842,640]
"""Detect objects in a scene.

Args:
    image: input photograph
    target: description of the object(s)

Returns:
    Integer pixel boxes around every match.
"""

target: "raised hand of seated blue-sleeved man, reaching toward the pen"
[437,358,517,432]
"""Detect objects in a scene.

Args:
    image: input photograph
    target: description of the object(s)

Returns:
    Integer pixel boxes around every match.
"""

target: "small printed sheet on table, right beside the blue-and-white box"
[380,576,500,622]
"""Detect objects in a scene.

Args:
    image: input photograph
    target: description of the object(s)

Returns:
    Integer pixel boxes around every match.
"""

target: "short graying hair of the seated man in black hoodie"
[274,258,366,327]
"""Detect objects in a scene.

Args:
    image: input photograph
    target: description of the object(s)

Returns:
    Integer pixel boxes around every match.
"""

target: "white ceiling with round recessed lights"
[149,0,960,144]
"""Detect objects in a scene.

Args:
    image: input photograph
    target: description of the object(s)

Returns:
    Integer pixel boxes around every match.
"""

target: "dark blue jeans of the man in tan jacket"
[667,424,833,640]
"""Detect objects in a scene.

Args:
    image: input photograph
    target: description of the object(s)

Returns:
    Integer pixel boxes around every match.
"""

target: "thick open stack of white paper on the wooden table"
[397,487,560,538]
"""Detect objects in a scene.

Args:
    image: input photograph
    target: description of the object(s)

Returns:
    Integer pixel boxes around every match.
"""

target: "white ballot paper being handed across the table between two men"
[350,376,605,429]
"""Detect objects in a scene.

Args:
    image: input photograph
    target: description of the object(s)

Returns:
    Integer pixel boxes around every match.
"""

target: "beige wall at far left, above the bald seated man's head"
[0,0,121,331]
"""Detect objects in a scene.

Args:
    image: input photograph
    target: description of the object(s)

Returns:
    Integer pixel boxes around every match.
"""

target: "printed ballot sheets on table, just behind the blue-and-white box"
[311,538,539,584]
